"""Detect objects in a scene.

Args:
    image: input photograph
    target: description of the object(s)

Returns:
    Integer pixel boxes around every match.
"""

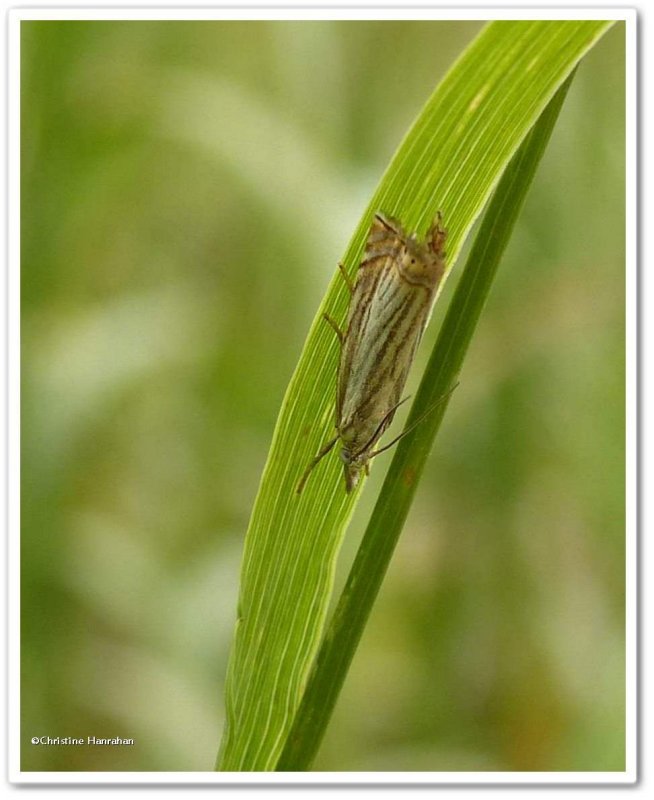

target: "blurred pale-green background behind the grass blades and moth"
[21,22,625,770]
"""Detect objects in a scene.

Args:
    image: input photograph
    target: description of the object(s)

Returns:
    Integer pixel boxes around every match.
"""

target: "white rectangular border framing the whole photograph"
[7,3,638,787]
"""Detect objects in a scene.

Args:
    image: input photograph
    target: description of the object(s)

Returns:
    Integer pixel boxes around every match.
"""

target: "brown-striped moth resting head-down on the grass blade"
[297,212,447,494]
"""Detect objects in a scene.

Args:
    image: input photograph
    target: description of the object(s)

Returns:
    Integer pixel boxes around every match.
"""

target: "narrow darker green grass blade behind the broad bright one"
[277,76,572,771]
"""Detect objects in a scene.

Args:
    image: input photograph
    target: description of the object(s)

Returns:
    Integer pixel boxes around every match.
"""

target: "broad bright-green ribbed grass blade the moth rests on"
[218,21,611,770]
